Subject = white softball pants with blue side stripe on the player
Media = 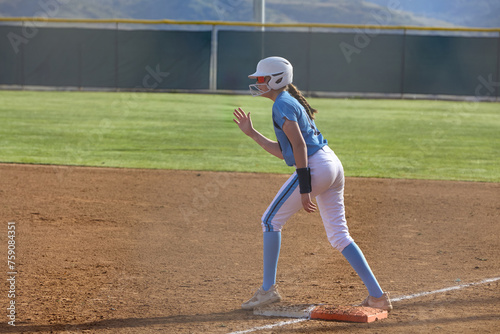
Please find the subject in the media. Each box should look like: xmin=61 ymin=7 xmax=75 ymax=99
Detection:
xmin=262 ymin=146 xmax=353 ymax=251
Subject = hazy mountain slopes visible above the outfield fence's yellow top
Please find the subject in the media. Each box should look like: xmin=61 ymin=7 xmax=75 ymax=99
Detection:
xmin=0 ymin=0 xmax=500 ymax=27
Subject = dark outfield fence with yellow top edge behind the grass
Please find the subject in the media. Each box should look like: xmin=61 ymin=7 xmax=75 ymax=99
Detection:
xmin=0 ymin=18 xmax=500 ymax=99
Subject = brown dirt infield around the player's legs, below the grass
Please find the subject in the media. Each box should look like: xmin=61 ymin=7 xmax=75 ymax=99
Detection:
xmin=0 ymin=165 xmax=500 ymax=333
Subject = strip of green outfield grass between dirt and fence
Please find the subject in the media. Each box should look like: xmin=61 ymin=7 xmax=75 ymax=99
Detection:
xmin=0 ymin=91 xmax=500 ymax=182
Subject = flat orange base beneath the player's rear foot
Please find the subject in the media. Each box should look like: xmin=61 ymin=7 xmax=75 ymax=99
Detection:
xmin=311 ymin=305 xmax=388 ymax=322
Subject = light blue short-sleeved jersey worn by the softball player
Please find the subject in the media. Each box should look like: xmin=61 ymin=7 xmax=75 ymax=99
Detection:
xmin=273 ymin=91 xmax=328 ymax=166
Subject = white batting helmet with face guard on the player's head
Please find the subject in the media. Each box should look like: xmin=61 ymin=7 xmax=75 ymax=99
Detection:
xmin=248 ymin=57 xmax=293 ymax=95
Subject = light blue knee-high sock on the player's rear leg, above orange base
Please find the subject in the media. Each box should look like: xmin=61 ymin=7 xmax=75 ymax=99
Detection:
xmin=342 ymin=242 xmax=384 ymax=298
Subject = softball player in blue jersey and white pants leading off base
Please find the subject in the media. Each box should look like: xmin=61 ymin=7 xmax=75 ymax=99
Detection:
xmin=233 ymin=57 xmax=392 ymax=311
